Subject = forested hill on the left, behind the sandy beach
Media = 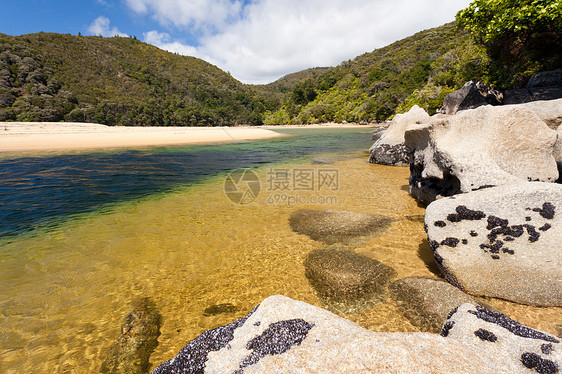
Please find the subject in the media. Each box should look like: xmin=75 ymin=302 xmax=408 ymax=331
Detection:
xmin=0 ymin=33 xmax=272 ymax=126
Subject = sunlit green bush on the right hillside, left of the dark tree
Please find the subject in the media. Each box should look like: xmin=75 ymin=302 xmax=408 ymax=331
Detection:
xmin=262 ymin=23 xmax=489 ymax=124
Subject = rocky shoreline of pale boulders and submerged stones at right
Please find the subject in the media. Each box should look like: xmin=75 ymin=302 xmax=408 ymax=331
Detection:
xmin=141 ymin=73 xmax=562 ymax=374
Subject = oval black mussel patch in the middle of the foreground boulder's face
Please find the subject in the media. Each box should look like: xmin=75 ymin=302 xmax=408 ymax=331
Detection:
xmin=234 ymin=318 xmax=314 ymax=374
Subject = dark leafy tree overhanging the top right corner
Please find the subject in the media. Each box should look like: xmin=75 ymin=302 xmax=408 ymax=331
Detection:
xmin=456 ymin=0 xmax=562 ymax=89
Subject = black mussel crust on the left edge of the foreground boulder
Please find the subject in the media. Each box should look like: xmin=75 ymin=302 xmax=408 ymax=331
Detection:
xmin=152 ymin=305 xmax=259 ymax=374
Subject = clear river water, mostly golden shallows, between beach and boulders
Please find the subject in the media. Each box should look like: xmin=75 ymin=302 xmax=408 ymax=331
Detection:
xmin=0 ymin=130 xmax=560 ymax=373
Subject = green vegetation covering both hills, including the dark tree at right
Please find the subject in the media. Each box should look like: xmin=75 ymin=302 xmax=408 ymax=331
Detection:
xmin=0 ymin=0 xmax=552 ymax=126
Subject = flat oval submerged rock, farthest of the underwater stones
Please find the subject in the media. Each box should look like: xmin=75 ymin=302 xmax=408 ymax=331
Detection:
xmin=289 ymin=209 xmax=392 ymax=244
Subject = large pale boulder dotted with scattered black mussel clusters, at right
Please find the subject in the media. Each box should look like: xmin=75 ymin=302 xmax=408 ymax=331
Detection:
xmin=425 ymin=183 xmax=562 ymax=306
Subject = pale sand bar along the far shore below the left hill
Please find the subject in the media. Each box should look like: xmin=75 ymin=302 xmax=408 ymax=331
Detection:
xmin=0 ymin=122 xmax=286 ymax=152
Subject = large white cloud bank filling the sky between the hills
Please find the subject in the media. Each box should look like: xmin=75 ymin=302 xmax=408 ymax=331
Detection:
xmin=135 ymin=0 xmax=470 ymax=83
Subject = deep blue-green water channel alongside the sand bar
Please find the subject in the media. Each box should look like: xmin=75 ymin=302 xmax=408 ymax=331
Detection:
xmin=0 ymin=129 xmax=371 ymax=238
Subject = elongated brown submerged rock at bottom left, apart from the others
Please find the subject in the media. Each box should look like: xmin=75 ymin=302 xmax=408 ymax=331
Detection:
xmin=101 ymin=297 xmax=162 ymax=374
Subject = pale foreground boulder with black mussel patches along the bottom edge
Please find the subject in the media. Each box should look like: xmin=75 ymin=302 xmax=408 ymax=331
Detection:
xmin=153 ymin=296 xmax=561 ymax=374
